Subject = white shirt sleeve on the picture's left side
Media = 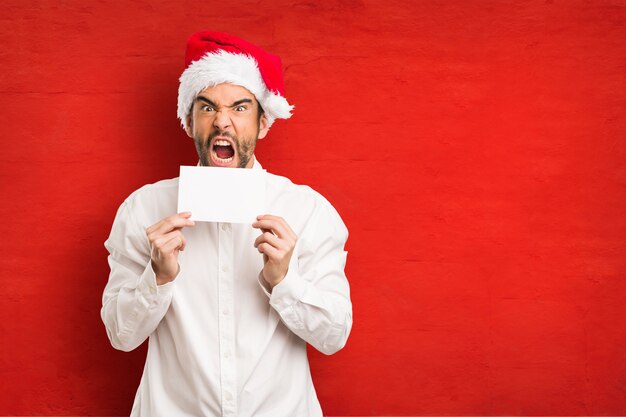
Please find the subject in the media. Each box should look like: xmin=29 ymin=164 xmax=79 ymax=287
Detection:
xmin=100 ymin=200 xmax=174 ymax=351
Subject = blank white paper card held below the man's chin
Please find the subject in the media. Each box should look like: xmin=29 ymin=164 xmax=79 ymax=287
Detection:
xmin=178 ymin=166 xmax=267 ymax=223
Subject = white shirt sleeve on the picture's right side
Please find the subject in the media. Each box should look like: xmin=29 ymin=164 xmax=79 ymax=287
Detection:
xmin=259 ymin=202 xmax=352 ymax=355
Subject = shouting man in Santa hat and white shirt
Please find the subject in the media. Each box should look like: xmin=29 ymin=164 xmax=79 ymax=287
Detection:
xmin=101 ymin=32 xmax=352 ymax=417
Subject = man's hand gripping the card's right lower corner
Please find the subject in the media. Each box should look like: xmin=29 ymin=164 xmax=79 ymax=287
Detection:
xmin=252 ymin=214 xmax=298 ymax=288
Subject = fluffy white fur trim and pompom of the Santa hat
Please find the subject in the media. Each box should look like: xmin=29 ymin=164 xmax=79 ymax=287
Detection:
xmin=178 ymin=51 xmax=294 ymax=132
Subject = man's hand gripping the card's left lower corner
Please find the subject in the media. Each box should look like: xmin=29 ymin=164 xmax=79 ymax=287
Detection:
xmin=146 ymin=212 xmax=195 ymax=285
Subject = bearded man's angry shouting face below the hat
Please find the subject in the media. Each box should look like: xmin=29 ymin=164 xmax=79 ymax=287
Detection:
xmin=186 ymin=83 xmax=268 ymax=168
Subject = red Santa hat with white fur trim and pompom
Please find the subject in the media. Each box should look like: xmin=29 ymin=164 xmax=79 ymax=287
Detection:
xmin=178 ymin=32 xmax=294 ymax=132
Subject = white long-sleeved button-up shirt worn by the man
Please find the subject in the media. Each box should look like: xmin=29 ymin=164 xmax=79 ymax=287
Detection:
xmin=101 ymin=161 xmax=352 ymax=417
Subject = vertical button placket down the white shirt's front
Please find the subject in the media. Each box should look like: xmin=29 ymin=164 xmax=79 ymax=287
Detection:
xmin=218 ymin=223 xmax=237 ymax=417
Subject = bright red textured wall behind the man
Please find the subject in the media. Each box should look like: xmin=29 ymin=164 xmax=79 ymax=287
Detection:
xmin=0 ymin=0 xmax=626 ymax=415
